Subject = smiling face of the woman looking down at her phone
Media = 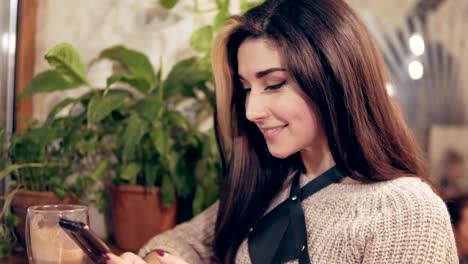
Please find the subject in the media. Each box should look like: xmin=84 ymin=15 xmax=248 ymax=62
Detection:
xmin=237 ymin=38 xmax=327 ymax=158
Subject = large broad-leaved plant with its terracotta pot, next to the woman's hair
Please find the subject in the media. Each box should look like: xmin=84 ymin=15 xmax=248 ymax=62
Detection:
xmin=93 ymin=43 xmax=221 ymax=251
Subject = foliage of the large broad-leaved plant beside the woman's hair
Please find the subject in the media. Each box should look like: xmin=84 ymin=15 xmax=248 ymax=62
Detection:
xmin=17 ymin=44 xmax=219 ymax=251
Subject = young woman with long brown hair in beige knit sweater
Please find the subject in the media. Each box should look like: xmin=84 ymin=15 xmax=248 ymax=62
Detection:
xmin=108 ymin=0 xmax=457 ymax=264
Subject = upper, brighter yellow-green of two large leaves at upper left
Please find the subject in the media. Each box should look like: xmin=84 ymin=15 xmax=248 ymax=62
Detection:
xmin=45 ymin=43 xmax=89 ymax=84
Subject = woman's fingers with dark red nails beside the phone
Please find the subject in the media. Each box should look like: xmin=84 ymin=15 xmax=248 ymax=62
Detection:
xmin=106 ymin=249 xmax=187 ymax=264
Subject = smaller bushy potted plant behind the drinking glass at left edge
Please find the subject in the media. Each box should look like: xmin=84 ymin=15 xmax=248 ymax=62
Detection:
xmin=0 ymin=118 xmax=82 ymax=253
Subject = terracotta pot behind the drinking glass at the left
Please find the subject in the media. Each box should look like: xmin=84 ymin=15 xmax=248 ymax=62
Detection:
xmin=11 ymin=190 xmax=79 ymax=242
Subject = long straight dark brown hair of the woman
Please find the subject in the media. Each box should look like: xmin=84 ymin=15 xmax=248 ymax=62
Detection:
xmin=212 ymin=0 xmax=426 ymax=263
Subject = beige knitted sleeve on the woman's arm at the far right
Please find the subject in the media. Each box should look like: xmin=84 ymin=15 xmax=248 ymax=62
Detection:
xmin=362 ymin=184 xmax=458 ymax=264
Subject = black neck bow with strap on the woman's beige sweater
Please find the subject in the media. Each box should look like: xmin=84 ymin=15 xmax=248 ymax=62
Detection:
xmin=248 ymin=166 xmax=344 ymax=264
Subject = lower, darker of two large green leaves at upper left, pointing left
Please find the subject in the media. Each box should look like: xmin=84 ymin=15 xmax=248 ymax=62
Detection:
xmin=19 ymin=70 xmax=83 ymax=100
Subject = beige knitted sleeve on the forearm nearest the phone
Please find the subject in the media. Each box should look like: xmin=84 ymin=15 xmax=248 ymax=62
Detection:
xmin=138 ymin=202 xmax=218 ymax=264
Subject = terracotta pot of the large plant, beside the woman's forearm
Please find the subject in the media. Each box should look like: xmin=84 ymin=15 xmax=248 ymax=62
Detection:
xmin=111 ymin=185 xmax=177 ymax=252
